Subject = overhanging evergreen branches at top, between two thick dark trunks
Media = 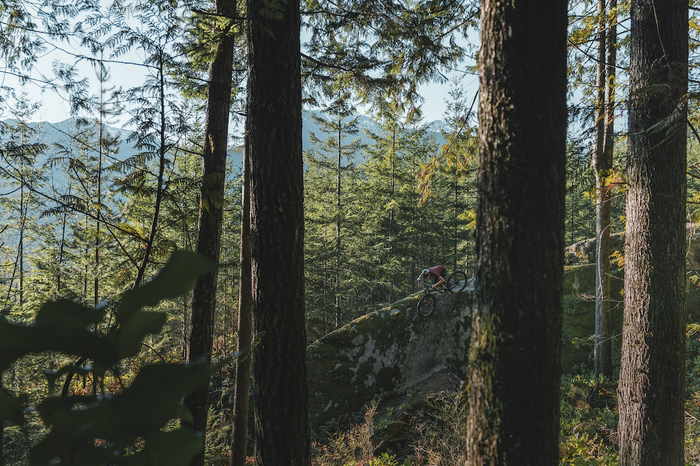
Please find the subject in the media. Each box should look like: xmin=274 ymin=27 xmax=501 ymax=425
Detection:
xmin=304 ymin=0 xmax=479 ymax=114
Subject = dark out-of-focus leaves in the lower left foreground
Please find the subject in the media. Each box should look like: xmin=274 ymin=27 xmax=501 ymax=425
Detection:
xmin=0 ymin=251 xmax=216 ymax=465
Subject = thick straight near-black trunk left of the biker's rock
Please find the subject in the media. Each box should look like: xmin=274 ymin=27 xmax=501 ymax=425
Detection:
xmin=246 ymin=0 xmax=311 ymax=466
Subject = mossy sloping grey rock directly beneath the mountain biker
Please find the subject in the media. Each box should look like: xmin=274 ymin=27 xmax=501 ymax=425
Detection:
xmin=307 ymin=283 xmax=473 ymax=428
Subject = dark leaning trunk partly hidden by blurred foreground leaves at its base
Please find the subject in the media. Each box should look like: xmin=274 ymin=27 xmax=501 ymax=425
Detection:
xmin=185 ymin=0 xmax=236 ymax=465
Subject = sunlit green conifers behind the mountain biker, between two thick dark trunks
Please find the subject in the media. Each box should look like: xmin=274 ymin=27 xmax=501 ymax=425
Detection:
xmin=304 ymin=104 xmax=475 ymax=337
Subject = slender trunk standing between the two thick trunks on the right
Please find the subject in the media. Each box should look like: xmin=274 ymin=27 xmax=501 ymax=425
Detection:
xmin=593 ymin=0 xmax=615 ymax=376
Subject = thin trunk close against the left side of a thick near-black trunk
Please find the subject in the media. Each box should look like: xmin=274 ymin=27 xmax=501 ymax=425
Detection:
xmin=231 ymin=140 xmax=253 ymax=466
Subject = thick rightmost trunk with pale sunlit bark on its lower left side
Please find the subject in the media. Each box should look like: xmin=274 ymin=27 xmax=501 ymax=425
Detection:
xmin=618 ymin=0 xmax=688 ymax=466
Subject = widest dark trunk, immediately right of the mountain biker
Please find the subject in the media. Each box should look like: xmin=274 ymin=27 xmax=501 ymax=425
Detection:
xmin=467 ymin=0 xmax=567 ymax=466
